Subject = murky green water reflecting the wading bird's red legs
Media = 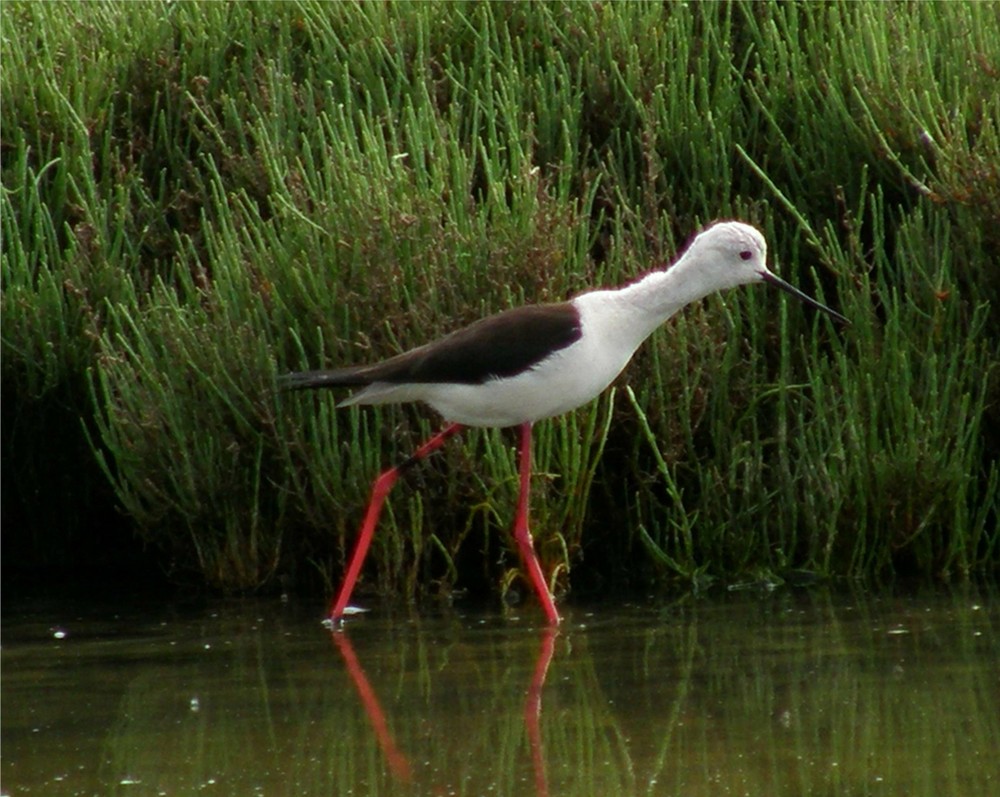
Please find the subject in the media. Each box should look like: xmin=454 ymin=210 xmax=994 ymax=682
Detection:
xmin=0 ymin=590 xmax=1000 ymax=797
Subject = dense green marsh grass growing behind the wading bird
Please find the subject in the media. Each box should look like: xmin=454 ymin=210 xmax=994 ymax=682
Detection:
xmin=0 ymin=2 xmax=1000 ymax=597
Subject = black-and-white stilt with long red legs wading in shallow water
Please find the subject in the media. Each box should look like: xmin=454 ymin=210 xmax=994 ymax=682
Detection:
xmin=282 ymin=221 xmax=847 ymax=624
